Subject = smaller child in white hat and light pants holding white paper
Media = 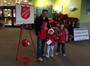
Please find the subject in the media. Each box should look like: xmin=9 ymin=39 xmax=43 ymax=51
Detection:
xmin=46 ymin=29 xmax=58 ymax=58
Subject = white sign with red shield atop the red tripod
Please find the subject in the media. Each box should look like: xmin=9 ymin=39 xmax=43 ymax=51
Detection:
xmin=16 ymin=4 xmax=34 ymax=24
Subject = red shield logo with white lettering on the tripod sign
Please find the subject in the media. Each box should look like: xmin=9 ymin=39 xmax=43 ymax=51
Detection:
xmin=21 ymin=5 xmax=30 ymax=20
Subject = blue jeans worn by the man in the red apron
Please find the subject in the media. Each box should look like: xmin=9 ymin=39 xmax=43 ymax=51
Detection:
xmin=37 ymin=40 xmax=45 ymax=58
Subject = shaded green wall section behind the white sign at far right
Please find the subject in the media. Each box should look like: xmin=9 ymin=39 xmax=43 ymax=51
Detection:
xmin=80 ymin=0 xmax=90 ymax=35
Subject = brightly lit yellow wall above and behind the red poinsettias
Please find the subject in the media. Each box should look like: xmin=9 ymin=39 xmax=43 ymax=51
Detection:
xmin=33 ymin=0 xmax=81 ymax=18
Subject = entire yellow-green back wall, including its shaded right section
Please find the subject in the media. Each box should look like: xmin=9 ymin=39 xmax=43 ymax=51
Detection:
xmin=33 ymin=0 xmax=90 ymax=34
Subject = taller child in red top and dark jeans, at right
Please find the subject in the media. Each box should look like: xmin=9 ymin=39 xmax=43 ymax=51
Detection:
xmin=56 ymin=24 xmax=66 ymax=56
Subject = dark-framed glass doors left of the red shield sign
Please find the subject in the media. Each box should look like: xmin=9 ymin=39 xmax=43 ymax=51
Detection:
xmin=0 ymin=6 xmax=19 ymax=27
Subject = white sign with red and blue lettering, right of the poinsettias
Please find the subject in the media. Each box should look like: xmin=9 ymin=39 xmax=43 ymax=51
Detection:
xmin=74 ymin=28 xmax=89 ymax=41
